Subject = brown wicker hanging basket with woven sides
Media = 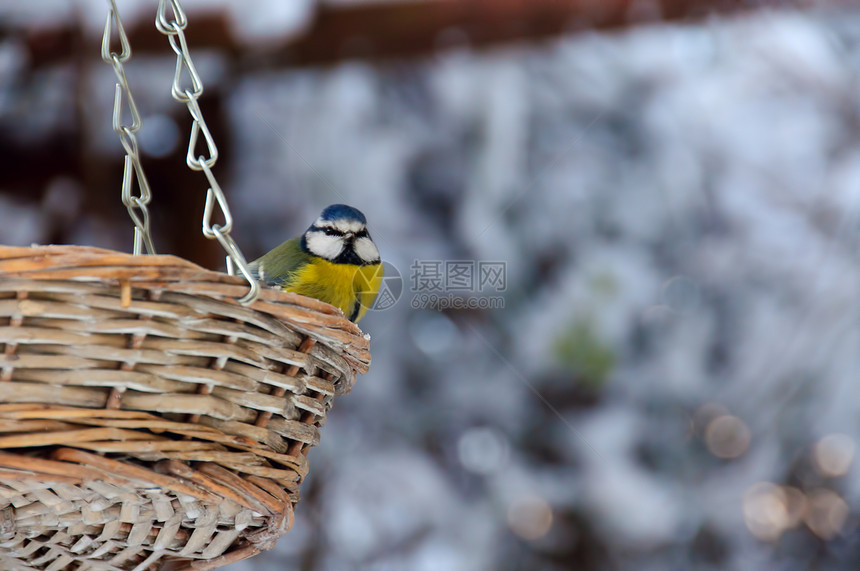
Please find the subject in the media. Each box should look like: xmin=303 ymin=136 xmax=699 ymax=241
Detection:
xmin=0 ymin=246 xmax=370 ymax=571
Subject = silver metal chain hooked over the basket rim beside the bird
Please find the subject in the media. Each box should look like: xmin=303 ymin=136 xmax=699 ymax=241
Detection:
xmin=155 ymin=0 xmax=260 ymax=305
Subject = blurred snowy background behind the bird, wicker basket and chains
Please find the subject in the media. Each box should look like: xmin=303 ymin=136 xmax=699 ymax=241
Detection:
xmin=0 ymin=0 xmax=860 ymax=571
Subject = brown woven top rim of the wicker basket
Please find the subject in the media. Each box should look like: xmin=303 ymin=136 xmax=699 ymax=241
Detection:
xmin=0 ymin=245 xmax=370 ymax=373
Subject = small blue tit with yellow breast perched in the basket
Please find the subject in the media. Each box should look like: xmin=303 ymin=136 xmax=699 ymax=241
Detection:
xmin=250 ymin=204 xmax=383 ymax=323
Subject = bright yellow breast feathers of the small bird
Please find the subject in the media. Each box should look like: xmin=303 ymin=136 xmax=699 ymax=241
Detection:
xmin=284 ymin=258 xmax=383 ymax=323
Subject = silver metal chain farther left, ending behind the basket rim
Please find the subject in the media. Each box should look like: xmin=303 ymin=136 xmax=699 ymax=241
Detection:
xmin=102 ymin=0 xmax=155 ymax=255
